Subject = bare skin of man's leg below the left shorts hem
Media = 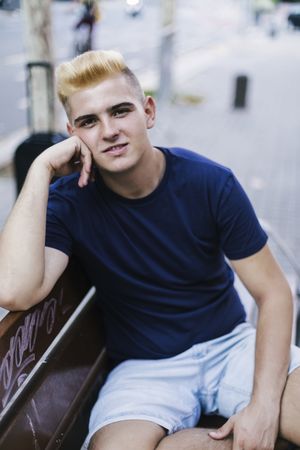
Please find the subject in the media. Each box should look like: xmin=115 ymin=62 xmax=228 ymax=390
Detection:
xmin=89 ymin=420 xmax=166 ymax=450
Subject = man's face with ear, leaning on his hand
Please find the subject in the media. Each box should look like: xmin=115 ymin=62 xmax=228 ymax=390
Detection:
xmin=68 ymin=75 xmax=155 ymax=173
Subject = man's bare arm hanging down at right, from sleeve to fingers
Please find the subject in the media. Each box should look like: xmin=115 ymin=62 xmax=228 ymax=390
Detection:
xmin=210 ymin=245 xmax=293 ymax=450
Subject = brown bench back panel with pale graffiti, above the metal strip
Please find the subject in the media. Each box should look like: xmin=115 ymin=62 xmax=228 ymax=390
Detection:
xmin=0 ymin=264 xmax=91 ymax=412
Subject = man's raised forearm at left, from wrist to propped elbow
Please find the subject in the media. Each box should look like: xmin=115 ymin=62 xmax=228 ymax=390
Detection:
xmin=0 ymin=161 xmax=51 ymax=309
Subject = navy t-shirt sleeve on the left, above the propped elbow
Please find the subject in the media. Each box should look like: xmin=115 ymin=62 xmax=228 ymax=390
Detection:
xmin=45 ymin=191 xmax=72 ymax=256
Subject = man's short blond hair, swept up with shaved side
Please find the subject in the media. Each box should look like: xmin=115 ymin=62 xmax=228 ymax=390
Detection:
xmin=56 ymin=50 xmax=144 ymax=108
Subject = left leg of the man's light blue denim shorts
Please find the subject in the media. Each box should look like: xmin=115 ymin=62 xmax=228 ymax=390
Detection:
xmin=83 ymin=354 xmax=200 ymax=449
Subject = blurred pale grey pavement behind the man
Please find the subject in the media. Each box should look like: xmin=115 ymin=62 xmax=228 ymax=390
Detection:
xmin=0 ymin=26 xmax=300 ymax=284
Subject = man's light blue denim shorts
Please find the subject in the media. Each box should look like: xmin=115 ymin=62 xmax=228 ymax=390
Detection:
xmin=83 ymin=323 xmax=300 ymax=449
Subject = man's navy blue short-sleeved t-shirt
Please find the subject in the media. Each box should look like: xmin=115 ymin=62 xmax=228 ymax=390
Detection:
xmin=46 ymin=148 xmax=267 ymax=361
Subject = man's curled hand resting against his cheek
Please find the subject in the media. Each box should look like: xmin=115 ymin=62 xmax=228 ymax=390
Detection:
xmin=34 ymin=136 xmax=92 ymax=187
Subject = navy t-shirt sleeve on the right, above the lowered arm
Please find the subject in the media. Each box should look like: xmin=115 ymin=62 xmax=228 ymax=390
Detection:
xmin=217 ymin=173 xmax=268 ymax=259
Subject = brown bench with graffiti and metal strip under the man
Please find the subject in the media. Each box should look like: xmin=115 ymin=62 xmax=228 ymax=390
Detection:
xmin=0 ymin=260 xmax=293 ymax=450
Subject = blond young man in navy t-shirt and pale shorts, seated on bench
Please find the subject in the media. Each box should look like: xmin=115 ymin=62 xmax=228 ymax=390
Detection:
xmin=0 ymin=51 xmax=300 ymax=450
